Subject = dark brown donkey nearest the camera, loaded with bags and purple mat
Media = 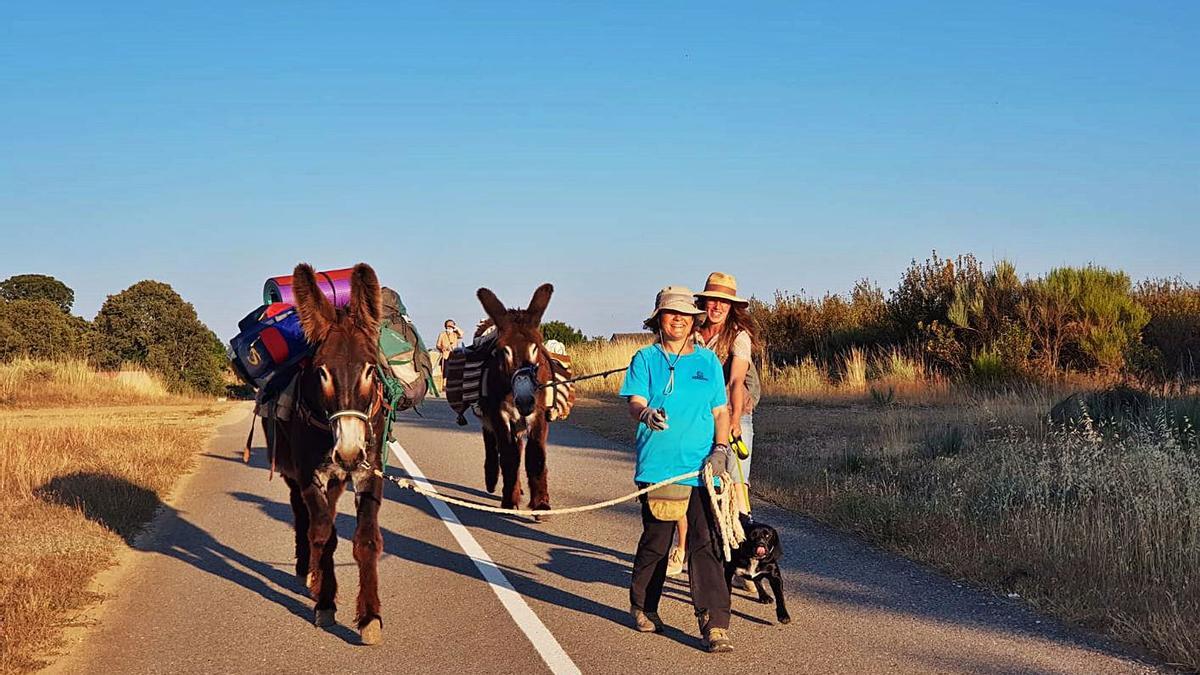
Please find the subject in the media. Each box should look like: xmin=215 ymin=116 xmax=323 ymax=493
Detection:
xmin=272 ymin=263 xmax=386 ymax=645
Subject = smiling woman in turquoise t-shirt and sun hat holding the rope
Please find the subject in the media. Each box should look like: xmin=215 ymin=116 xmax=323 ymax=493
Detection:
xmin=620 ymin=286 xmax=733 ymax=652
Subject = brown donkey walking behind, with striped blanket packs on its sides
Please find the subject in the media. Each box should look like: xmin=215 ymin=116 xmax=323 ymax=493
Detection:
xmin=476 ymin=283 xmax=554 ymax=510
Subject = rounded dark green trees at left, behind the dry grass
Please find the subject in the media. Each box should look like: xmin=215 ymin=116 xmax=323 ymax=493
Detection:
xmin=0 ymin=274 xmax=227 ymax=394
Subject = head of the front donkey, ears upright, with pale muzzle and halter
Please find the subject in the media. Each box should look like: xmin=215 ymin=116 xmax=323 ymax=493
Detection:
xmin=293 ymin=263 xmax=383 ymax=468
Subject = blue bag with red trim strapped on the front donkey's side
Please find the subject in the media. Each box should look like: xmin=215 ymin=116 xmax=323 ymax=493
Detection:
xmin=229 ymin=303 xmax=312 ymax=389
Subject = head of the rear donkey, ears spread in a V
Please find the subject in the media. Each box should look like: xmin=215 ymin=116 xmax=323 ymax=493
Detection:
xmin=476 ymin=283 xmax=554 ymax=416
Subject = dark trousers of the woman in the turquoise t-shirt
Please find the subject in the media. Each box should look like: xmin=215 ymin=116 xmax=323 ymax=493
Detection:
xmin=629 ymin=488 xmax=730 ymax=628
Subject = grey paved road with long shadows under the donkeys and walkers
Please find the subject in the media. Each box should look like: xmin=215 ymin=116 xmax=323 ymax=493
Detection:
xmin=53 ymin=401 xmax=1161 ymax=675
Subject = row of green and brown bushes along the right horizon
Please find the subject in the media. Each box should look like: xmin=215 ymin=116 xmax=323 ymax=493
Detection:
xmin=751 ymin=252 xmax=1200 ymax=380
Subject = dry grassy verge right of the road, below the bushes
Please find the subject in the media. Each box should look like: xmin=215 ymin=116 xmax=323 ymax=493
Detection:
xmin=561 ymin=338 xmax=1200 ymax=670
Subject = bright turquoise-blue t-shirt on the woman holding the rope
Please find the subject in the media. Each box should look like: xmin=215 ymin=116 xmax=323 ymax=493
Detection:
xmin=620 ymin=345 xmax=726 ymax=485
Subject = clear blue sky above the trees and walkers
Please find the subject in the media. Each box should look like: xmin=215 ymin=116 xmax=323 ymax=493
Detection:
xmin=0 ymin=0 xmax=1200 ymax=339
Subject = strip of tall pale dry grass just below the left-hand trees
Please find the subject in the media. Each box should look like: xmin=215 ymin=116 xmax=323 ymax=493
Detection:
xmin=0 ymin=358 xmax=186 ymax=407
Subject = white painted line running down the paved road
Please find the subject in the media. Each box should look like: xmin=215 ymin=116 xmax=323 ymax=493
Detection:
xmin=388 ymin=441 xmax=581 ymax=675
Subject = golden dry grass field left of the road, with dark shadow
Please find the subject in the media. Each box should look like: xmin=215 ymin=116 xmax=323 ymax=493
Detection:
xmin=0 ymin=362 xmax=221 ymax=673
